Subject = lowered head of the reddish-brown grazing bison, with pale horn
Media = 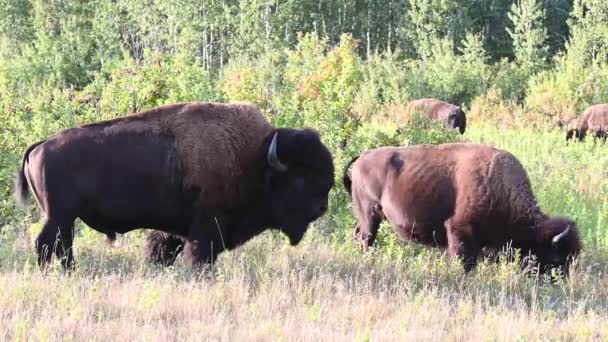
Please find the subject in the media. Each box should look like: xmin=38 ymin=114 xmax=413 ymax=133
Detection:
xmin=532 ymin=218 xmax=581 ymax=273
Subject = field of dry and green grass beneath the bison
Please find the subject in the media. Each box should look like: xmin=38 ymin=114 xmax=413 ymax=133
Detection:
xmin=0 ymin=127 xmax=608 ymax=341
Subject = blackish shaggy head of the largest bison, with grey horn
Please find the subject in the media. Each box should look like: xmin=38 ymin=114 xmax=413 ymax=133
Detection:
xmin=265 ymin=128 xmax=334 ymax=245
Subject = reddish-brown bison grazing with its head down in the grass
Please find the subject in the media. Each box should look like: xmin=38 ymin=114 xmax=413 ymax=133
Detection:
xmin=343 ymin=143 xmax=581 ymax=271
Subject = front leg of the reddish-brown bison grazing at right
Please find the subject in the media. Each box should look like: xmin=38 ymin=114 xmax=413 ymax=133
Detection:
xmin=445 ymin=220 xmax=481 ymax=273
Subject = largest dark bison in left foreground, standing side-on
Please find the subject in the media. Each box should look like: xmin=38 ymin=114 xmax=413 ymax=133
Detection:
xmin=16 ymin=103 xmax=334 ymax=268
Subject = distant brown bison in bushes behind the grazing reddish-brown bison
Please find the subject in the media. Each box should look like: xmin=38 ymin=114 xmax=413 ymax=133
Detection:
xmin=406 ymin=99 xmax=467 ymax=134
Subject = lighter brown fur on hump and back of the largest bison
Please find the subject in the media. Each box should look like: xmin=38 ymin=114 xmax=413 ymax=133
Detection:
xmin=85 ymin=102 xmax=273 ymax=208
